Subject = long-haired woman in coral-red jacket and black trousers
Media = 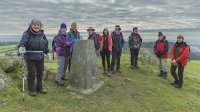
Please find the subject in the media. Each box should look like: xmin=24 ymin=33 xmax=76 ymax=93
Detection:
xmin=99 ymin=28 xmax=112 ymax=76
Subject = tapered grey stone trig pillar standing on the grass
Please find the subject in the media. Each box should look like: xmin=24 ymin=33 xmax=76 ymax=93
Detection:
xmin=68 ymin=40 xmax=103 ymax=94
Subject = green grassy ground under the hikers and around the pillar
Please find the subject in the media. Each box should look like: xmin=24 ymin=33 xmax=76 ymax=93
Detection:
xmin=0 ymin=54 xmax=200 ymax=112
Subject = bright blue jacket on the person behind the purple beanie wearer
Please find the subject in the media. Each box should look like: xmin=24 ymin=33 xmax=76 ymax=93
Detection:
xmin=67 ymin=30 xmax=80 ymax=46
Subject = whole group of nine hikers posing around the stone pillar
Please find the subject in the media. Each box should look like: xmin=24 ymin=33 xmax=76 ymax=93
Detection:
xmin=18 ymin=19 xmax=189 ymax=96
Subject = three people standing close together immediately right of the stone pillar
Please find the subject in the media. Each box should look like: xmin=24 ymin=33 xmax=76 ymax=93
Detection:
xmin=87 ymin=25 xmax=125 ymax=76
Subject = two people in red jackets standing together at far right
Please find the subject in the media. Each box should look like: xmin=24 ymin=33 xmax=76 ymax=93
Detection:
xmin=154 ymin=32 xmax=190 ymax=88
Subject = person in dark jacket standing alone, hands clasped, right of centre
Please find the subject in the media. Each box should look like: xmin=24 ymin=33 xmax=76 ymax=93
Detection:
xmin=129 ymin=27 xmax=142 ymax=68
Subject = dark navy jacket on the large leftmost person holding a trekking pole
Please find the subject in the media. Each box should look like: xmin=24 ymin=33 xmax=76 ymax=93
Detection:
xmin=19 ymin=27 xmax=49 ymax=60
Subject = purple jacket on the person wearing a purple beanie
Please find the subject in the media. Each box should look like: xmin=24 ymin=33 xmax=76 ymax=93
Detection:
xmin=56 ymin=32 xmax=72 ymax=56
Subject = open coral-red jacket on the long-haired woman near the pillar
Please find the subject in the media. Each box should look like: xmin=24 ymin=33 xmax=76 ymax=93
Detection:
xmin=99 ymin=35 xmax=112 ymax=52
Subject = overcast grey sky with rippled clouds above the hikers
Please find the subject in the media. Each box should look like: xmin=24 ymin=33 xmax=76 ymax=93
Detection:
xmin=0 ymin=0 xmax=200 ymax=34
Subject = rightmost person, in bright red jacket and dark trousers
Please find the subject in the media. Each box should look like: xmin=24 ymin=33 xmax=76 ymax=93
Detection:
xmin=171 ymin=35 xmax=190 ymax=88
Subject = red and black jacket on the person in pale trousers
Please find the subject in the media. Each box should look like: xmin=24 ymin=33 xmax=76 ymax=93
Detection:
xmin=154 ymin=37 xmax=169 ymax=59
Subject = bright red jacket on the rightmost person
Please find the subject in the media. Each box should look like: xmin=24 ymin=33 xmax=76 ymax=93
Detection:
xmin=170 ymin=42 xmax=190 ymax=66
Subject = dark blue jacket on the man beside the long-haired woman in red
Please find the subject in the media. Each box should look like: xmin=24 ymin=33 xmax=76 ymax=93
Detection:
xmin=111 ymin=32 xmax=125 ymax=53
